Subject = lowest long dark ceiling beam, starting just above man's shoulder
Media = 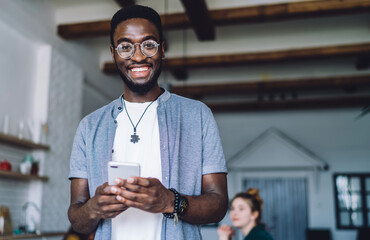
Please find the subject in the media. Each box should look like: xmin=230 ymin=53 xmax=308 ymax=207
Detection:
xmin=206 ymin=96 xmax=370 ymax=113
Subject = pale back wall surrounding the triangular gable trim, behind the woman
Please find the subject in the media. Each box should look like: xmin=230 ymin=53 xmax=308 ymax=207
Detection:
xmin=205 ymin=108 xmax=370 ymax=240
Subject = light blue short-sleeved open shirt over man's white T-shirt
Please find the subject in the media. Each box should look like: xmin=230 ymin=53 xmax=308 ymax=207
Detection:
xmin=69 ymin=91 xmax=227 ymax=240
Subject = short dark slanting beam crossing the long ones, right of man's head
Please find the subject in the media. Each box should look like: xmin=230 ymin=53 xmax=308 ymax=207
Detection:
xmin=181 ymin=0 xmax=215 ymax=41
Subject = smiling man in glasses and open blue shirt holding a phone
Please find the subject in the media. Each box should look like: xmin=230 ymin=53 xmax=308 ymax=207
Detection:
xmin=68 ymin=5 xmax=228 ymax=240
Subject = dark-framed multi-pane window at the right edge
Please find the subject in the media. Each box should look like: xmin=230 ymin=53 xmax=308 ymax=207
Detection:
xmin=334 ymin=173 xmax=370 ymax=229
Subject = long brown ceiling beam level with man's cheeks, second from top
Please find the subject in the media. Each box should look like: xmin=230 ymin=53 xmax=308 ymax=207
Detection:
xmin=103 ymin=43 xmax=370 ymax=74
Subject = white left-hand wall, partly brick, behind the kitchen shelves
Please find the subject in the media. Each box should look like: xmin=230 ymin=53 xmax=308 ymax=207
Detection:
xmin=0 ymin=0 xmax=84 ymax=234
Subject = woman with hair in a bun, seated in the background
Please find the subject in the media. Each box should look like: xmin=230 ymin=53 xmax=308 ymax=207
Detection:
xmin=217 ymin=188 xmax=273 ymax=240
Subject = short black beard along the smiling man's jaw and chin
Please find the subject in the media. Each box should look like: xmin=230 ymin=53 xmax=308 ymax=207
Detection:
xmin=114 ymin=59 xmax=162 ymax=95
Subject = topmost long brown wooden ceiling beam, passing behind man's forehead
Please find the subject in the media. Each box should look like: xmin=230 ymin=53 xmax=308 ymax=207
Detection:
xmin=58 ymin=0 xmax=370 ymax=39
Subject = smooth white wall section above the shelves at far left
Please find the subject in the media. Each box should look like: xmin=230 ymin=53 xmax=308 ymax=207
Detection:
xmin=0 ymin=17 xmax=39 ymax=135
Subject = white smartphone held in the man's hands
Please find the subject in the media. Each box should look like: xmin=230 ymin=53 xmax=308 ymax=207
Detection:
xmin=108 ymin=161 xmax=140 ymax=185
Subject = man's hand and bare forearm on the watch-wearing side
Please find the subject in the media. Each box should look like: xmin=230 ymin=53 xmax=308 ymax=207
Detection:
xmin=109 ymin=173 xmax=228 ymax=224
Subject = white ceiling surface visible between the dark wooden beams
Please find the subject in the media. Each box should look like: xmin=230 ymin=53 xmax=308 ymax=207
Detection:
xmin=31 ymin=0 xmax=370 ymax=103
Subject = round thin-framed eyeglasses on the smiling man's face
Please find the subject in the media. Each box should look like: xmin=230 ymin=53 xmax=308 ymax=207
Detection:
xmin=116 ymin=40 xmax=160 ymax=59
